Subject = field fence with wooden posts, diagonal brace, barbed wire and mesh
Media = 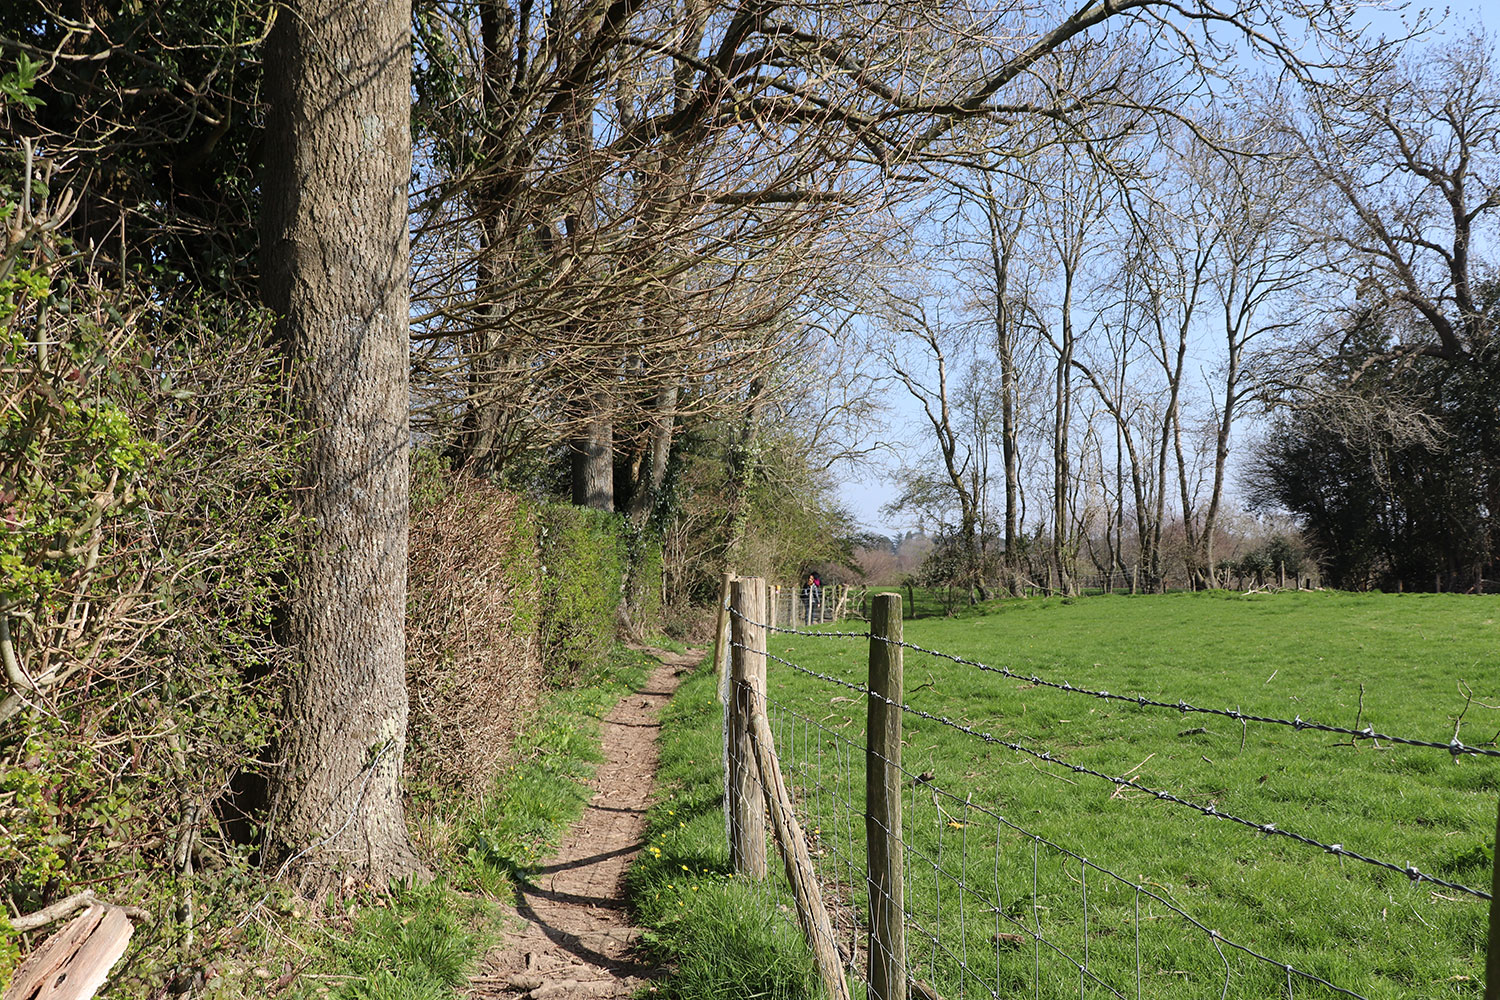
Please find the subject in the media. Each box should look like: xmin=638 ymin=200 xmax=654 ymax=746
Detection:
xmin=716 ymin=574 xmax=1500 ymax=1000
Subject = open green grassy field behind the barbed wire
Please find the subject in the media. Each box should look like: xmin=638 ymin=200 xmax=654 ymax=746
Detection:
xmin=741 ymin=592 xmax=1500 ymax=999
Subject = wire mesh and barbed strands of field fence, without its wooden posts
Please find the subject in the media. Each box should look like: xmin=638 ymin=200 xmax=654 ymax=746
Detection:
xmin=728 ymin=578 xmax=1496 ymax=1000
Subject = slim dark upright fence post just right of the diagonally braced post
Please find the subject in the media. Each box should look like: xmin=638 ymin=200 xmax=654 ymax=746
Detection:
xmin=864 ymin=594 xmax=906 ymax=1000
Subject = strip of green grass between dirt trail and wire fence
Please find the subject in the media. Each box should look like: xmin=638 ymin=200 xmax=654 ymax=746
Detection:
xmin=626 ymin=660 xmax=818 ymax=1000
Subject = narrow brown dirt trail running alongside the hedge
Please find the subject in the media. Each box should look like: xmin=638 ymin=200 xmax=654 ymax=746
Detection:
xmin=465 ymin=649 xmax=704 ymax=1000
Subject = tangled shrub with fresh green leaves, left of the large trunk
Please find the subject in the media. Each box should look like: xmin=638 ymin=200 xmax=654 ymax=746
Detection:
xmin=0 ymin=176 xmax=297 ymax=993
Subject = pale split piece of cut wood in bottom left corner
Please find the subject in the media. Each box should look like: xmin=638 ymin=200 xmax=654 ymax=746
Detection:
xmin=5 ymin=903 xmax=135 ymax=1000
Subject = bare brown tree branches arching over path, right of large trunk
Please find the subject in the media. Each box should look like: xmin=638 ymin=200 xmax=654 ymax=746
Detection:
xmin=405 ymin=0 xmax=1368 ymax=517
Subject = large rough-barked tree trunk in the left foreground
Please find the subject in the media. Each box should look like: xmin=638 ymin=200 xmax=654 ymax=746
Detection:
xmin=263 ymin=0 xmax=420 ymax=889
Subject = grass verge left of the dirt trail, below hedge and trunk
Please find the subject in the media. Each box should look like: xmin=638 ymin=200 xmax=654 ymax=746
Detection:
xmin=214 ymin=649 xmax=654 ymax=1000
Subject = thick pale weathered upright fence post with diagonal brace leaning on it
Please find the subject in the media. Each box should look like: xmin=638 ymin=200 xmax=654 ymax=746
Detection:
xmin=728 ymin=577 xmax=767 ymax=879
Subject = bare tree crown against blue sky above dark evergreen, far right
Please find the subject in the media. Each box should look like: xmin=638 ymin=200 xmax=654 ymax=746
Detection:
xmin=1277 ymin=31 xmax=1500 ymax=361
